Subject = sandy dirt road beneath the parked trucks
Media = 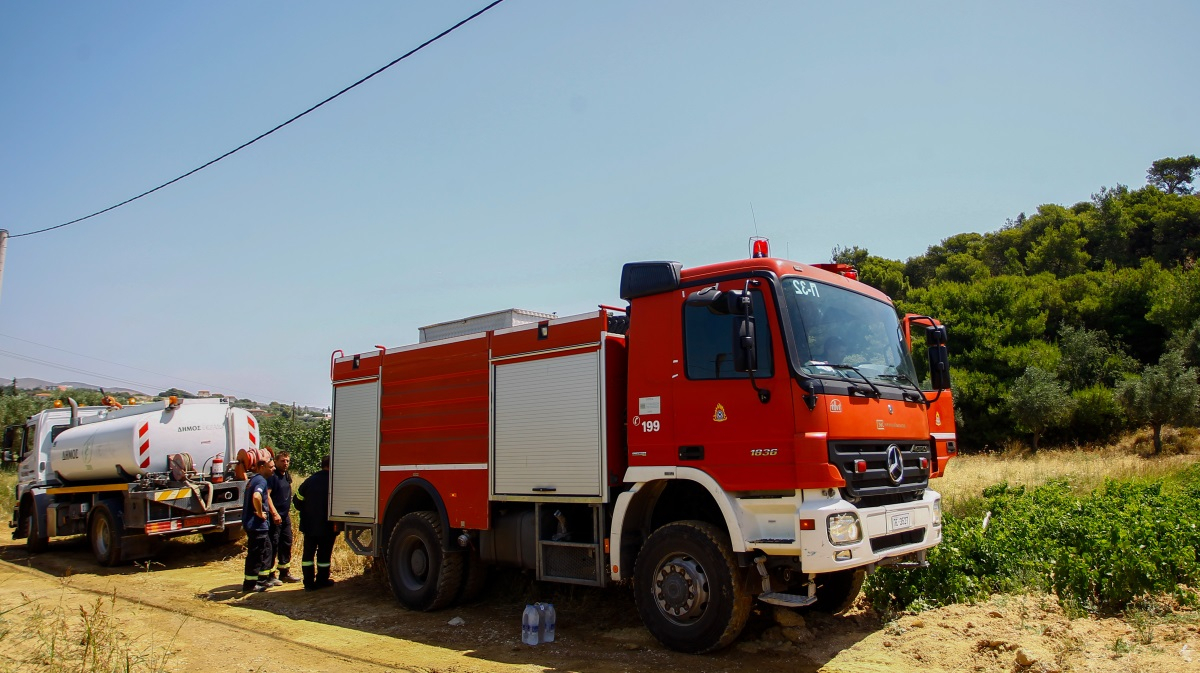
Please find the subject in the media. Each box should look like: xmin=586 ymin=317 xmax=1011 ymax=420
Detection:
xmin=0 ymin=532 xmax=1200 ymax=673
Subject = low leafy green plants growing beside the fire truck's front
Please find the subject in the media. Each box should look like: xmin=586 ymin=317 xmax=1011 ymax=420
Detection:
xmin=866 ymin=465 xmax=1200 ymax=613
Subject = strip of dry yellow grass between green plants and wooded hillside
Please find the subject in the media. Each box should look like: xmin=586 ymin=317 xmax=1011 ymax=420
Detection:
xmin=934 ymin=428 xmax=1200 ymax=512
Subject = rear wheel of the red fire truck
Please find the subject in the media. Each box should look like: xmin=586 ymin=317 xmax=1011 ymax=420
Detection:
xmin=388 ymin=512 xmax=462 ymax=612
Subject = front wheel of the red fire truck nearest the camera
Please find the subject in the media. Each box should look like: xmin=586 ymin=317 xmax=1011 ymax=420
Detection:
xmin=634 ymin=521 xmax=752 ymax=654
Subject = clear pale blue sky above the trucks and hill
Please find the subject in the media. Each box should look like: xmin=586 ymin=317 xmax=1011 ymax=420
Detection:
xmin=0 ymin=0 xmax=1200 ymax=405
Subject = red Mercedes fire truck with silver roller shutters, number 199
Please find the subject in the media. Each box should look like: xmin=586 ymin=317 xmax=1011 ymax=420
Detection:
xmin=330 ymin=241 xmax=956 ymax=653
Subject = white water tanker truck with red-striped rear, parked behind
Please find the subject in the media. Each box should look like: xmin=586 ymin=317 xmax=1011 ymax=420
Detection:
xmin=2 ymin=397 xmax=260 ymax=565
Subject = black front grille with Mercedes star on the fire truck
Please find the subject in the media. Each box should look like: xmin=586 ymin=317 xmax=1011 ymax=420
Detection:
xmin=829 ymin=440 xmax=932 ymax=507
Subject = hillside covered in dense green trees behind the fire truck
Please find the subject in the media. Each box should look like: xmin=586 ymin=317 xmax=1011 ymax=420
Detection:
xmin=833 ymin=155 xmax=1200 ymax=452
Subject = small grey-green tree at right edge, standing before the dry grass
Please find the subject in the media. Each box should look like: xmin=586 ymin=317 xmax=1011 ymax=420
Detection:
xmin=1117 ymin=350 xmax=1200 ymax=455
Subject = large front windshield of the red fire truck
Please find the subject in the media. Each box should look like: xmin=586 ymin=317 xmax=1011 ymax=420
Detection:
xmin=781 ymin=276 xmax=917 ymax=387
